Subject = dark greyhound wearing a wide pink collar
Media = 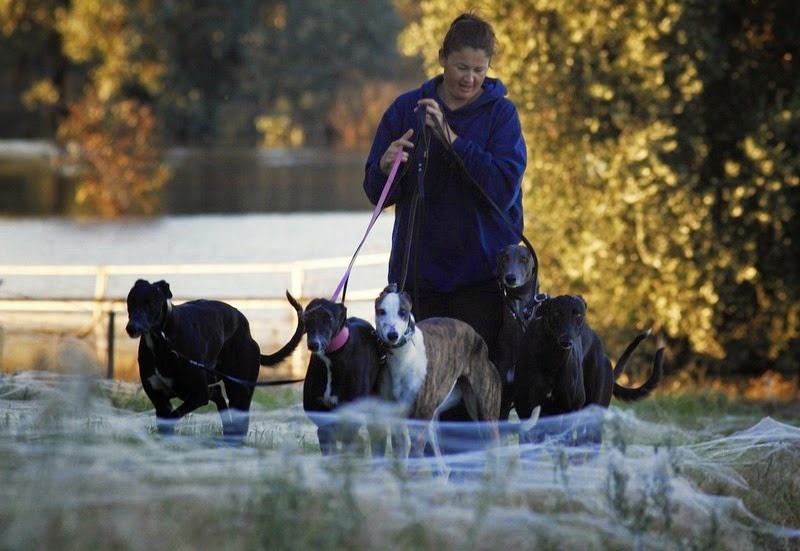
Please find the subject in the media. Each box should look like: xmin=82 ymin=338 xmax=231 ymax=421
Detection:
xmin=289 ymin=295 xmax=386 ymax=456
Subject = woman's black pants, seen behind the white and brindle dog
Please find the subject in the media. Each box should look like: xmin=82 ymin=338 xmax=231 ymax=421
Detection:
xmin=406 ymin=280 xmax=503 ymax=432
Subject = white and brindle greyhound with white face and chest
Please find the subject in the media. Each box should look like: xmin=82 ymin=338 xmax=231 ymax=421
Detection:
xmin=375 ymin=284 xmax=501 ymax=458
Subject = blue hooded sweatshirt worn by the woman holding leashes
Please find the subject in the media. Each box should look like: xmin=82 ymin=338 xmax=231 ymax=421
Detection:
xmin=364 ymin=75 xmax=527 ymax=293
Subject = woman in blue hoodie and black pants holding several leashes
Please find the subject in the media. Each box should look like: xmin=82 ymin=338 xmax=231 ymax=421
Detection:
xmin=364 ymin=14 xmax=527 ymax=357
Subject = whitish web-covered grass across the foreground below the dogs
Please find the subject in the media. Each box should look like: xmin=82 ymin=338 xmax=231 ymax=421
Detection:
xmin=0 ymin=372 xmax=800 ymax=549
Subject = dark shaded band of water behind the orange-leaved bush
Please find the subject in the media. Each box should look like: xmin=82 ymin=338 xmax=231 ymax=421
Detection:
xmin=0 ymin=141 xmax=371 ymax=216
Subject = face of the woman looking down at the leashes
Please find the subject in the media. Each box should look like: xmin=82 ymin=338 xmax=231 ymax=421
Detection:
xmin=439 ymin=48 xmax=490 ymax=109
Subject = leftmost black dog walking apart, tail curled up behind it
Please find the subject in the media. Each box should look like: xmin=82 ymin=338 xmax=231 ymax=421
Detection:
xmin=125 ymin=279 xmax=303 ymax=439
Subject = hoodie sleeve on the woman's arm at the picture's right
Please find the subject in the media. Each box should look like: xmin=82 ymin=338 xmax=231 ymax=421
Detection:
xmin=453 ymin=100 xmax=527 ymax=211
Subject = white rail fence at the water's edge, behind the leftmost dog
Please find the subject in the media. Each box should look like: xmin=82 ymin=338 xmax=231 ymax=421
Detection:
xmin=0 ymin=253 xmax=389 ymax=377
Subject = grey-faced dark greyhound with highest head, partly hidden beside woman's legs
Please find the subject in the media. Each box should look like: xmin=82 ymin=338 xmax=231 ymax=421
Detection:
xmin=492 ymin=245 xmax=542 ymax=421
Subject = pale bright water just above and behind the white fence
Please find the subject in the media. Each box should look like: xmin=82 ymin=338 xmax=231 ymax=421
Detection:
xmin=0 ymin=211 xmax=394 ymax=298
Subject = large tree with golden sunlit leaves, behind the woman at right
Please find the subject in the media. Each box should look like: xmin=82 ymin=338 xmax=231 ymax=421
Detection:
xmin=402 ymin=0 xmax=800 ymax=376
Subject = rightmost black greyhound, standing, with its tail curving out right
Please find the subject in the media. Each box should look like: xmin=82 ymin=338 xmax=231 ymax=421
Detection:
xmin=514 ymin=295 xmax=664 ymax=443
